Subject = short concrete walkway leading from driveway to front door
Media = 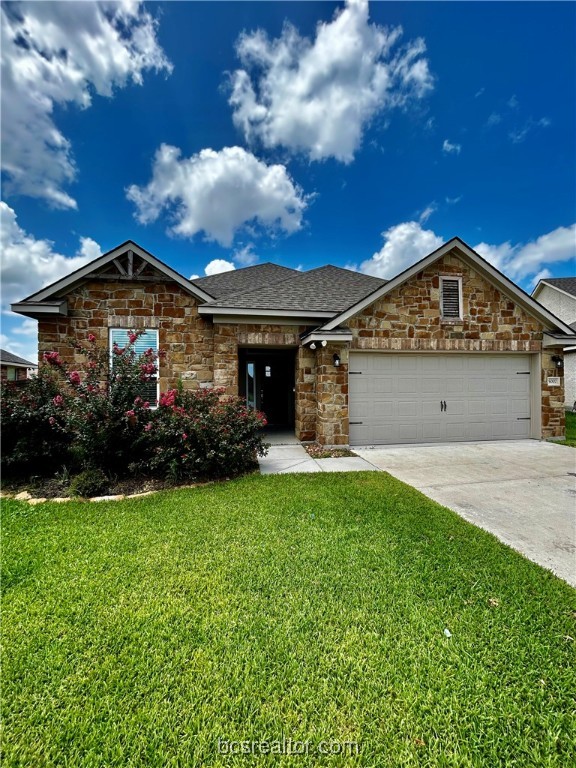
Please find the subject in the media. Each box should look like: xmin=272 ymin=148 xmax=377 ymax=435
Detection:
xmin=258 ymin=433 xmax=378 ymax=475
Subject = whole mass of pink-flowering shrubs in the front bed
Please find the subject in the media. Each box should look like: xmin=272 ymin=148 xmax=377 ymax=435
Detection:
xmin=1 ymin=331 xmax=267 ymax=495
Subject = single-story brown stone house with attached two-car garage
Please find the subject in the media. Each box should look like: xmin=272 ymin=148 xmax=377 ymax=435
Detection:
xmin=12 ymin=238 xmax=576 ymax=445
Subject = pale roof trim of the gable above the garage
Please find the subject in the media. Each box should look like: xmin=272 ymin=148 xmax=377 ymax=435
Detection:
xmin=323 ymin=237 xmax=573 ymax=335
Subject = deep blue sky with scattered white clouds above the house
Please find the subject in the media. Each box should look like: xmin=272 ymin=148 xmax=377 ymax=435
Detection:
xmin=0 ymin=0 xmax=576 ymax=359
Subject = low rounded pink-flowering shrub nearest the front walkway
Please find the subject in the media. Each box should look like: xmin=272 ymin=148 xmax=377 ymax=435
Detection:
xmin=144 ymin=389 xmax=267 ymax=480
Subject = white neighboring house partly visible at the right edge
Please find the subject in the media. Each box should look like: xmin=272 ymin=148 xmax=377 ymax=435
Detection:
xmin=532 ymin=277 xmax=576 ymax=408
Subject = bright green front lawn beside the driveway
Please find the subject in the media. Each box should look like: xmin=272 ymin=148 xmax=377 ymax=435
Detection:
xmin=2 ymin=473 xmax=576 ymax=768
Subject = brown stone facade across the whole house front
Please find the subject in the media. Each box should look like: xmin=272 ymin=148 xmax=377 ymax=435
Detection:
xmin=39 ymin=252 xmax=564 ymax=446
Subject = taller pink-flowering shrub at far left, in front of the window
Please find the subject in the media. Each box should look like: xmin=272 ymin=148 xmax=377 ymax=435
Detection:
xmin=2 ymin=331 xmax=157 ymax=476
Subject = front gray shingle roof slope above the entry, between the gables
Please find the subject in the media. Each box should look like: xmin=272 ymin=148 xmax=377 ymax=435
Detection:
xmin=205 ymin=265 xmax=386 ymax=313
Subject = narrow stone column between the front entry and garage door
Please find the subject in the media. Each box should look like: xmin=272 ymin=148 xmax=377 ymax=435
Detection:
xmin=316 ymin=344 xmax=349 ymax=446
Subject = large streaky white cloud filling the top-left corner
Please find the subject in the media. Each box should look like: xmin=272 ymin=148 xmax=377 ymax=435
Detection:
xmin=1 ymin=0 xmax=171 ymax=208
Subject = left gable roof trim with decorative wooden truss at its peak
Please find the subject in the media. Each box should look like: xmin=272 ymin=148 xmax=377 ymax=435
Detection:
xmin=13 ymin=240 xmax=213 ymax=312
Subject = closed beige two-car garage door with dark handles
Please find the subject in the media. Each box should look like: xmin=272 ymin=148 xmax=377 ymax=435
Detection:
xmin=349 ymin=352 xmax=530 ymax=445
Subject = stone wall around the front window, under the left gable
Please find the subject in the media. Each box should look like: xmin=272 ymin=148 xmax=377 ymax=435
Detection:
xmin=38 ymin=279 xmax=214 ymax=392
